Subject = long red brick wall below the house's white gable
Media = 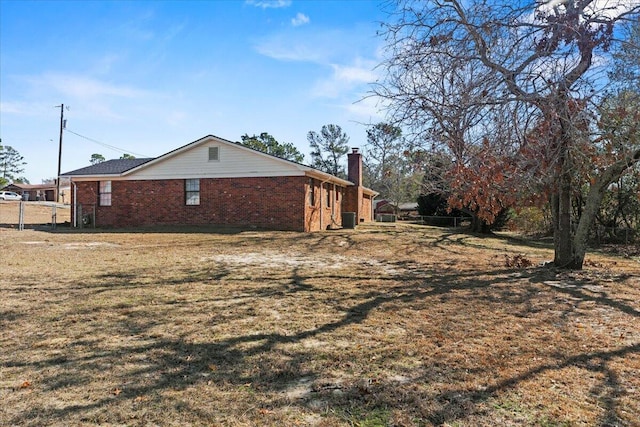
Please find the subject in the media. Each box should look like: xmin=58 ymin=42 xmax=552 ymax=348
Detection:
xmin=71 ymin=177 xmax=308 ymax=231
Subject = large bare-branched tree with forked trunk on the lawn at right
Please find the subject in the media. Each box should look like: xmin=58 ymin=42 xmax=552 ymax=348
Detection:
xmin=376 ymin=0 xmax=640 ymax=269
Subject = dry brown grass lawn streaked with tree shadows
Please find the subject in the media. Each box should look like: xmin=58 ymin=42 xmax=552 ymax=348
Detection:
xmin=0 ymin=222 xmax=640 ymax=426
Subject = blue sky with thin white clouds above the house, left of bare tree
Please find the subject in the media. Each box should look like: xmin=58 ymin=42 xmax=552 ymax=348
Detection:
xmin=0 ymin=0 xmax=386 ymax=184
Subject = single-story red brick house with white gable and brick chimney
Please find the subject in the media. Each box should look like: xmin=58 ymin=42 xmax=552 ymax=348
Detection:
xmin=62 ymin=135 xmax=377 ymax=231
